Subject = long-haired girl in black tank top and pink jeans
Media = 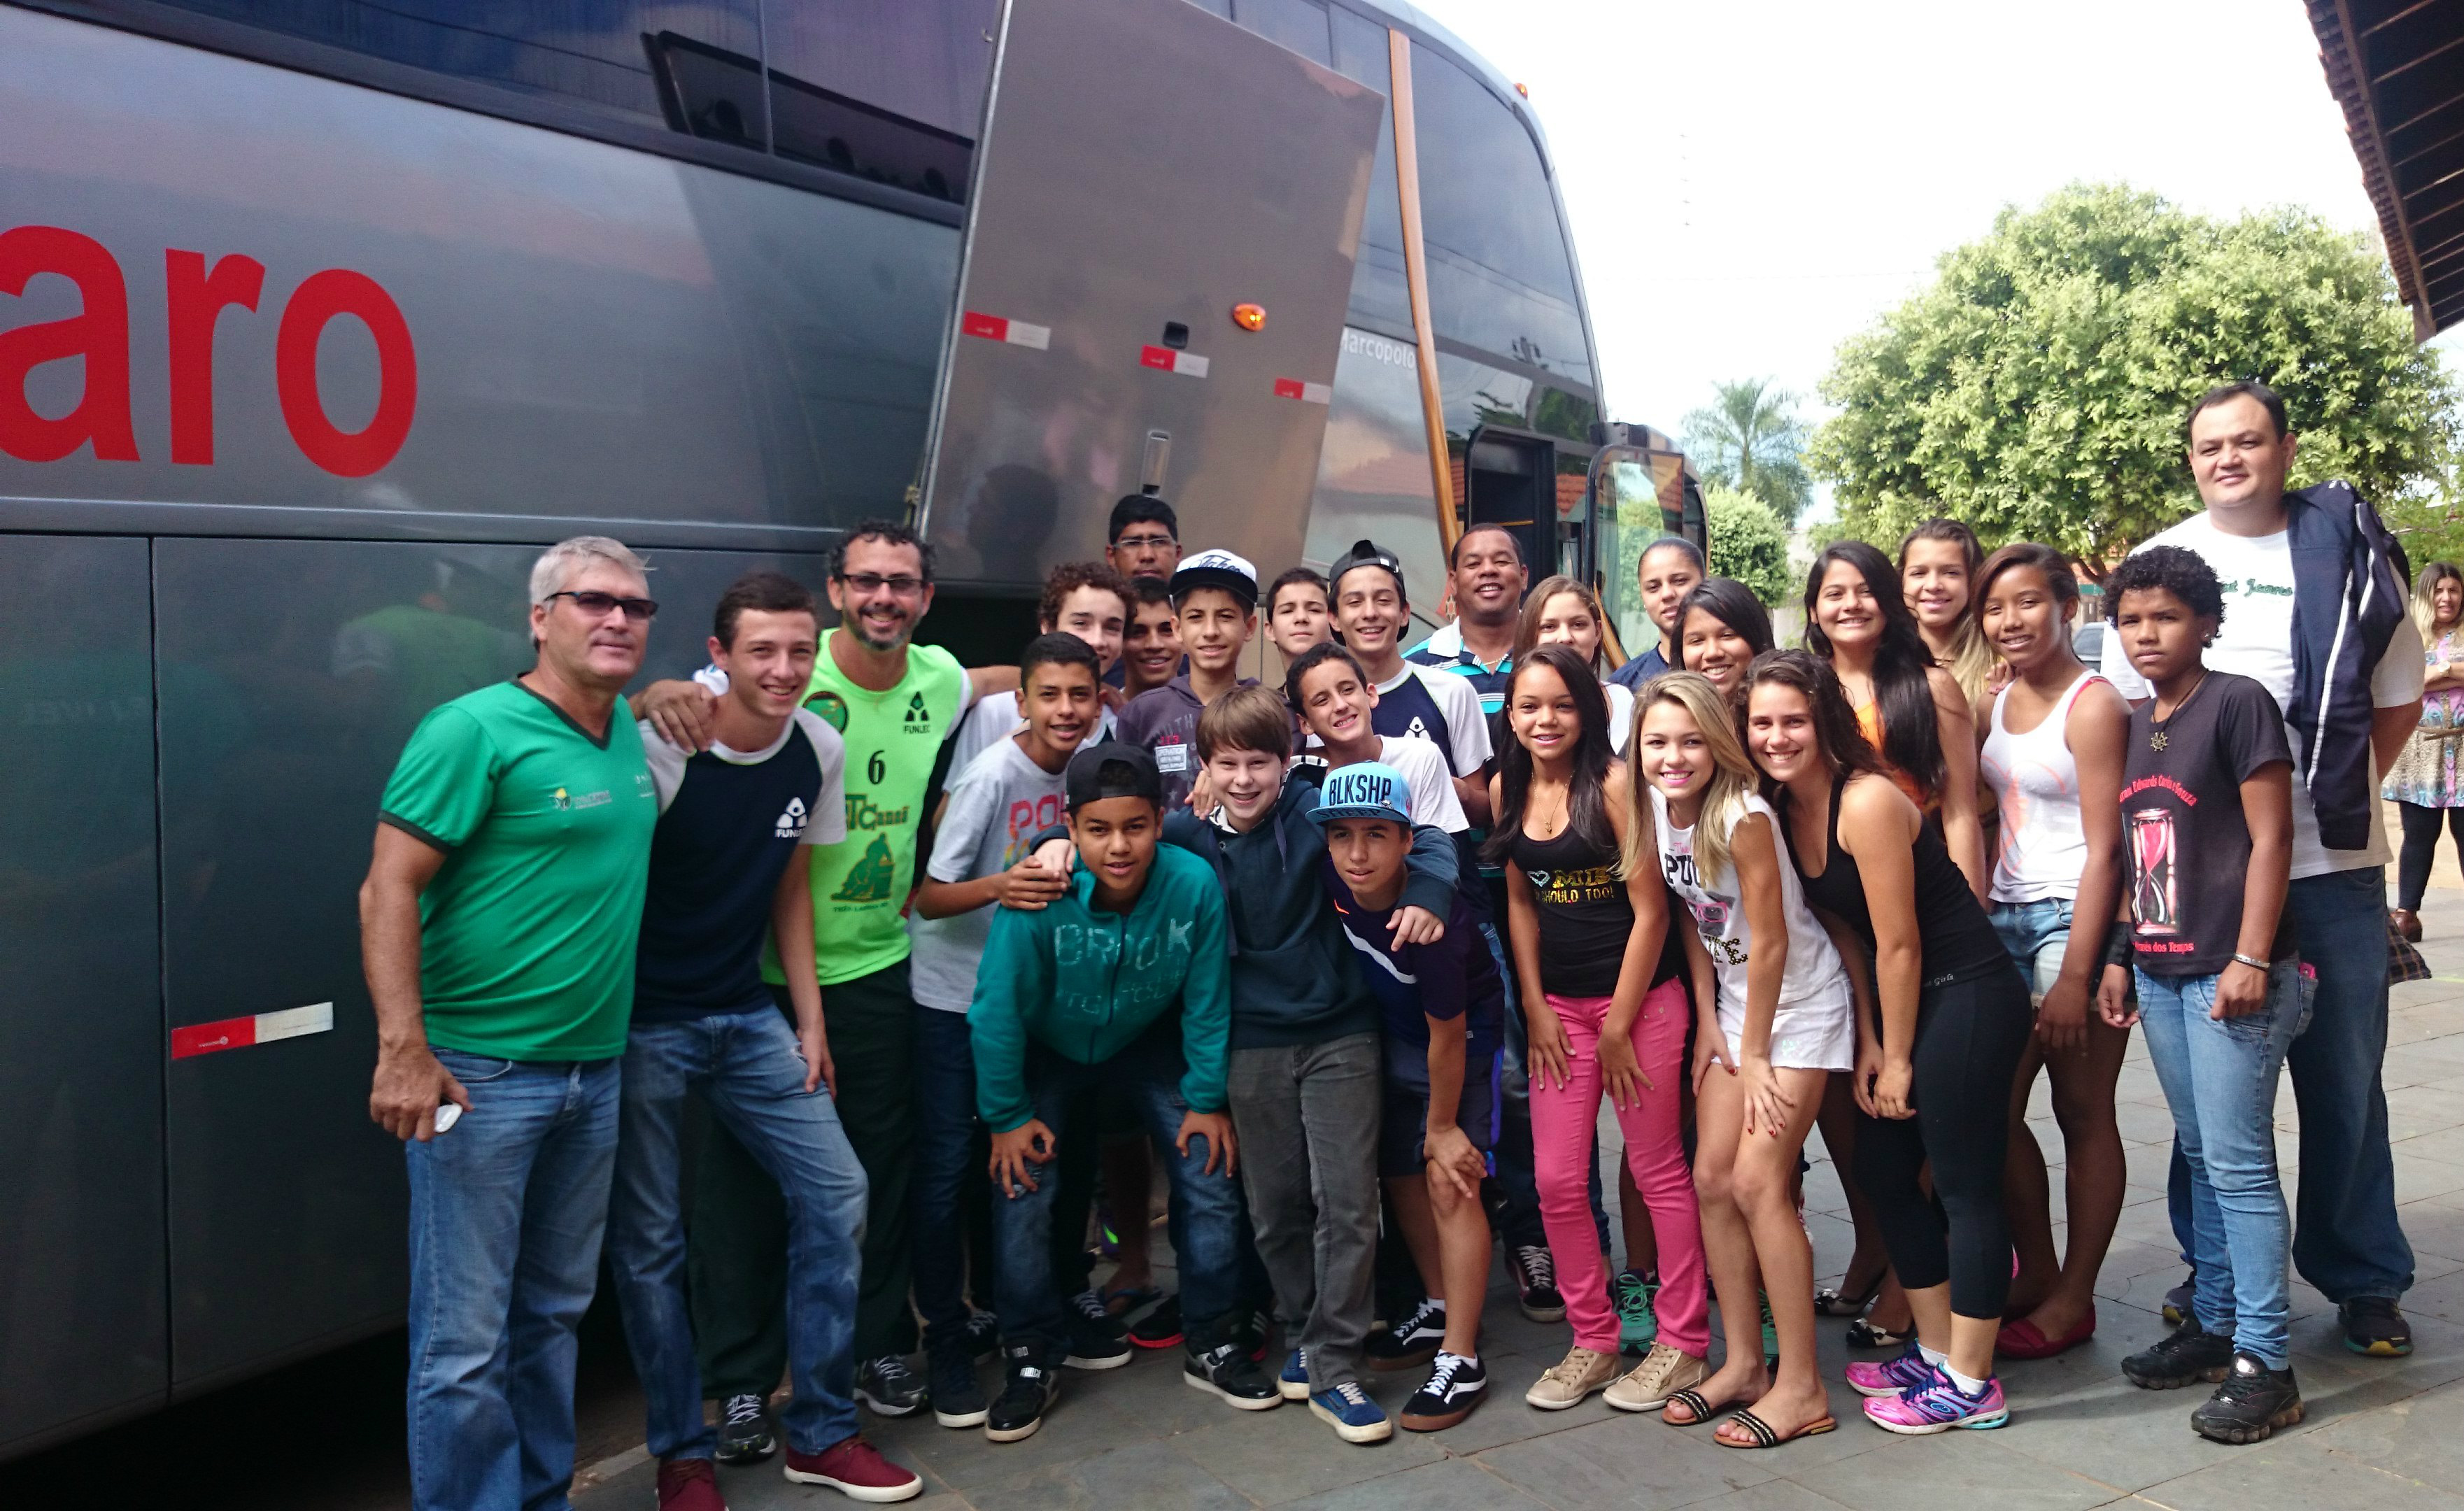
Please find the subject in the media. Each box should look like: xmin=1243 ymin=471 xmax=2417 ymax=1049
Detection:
xmin=1488 ymin=644 xmax=1710 ymax=1410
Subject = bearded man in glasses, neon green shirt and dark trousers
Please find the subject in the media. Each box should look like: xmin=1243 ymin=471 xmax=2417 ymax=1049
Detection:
xmin=636 ymin=520 xmax=995 ymax=1429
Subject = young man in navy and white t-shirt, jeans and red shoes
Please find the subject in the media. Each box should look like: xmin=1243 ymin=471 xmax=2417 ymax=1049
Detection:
xmin=609 ymin=572 xmax=924 ymax=1511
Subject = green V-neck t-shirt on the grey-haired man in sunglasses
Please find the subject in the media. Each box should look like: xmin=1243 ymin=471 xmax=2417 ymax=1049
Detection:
xmin=379 ymin=683 xmax=658 ymax=1060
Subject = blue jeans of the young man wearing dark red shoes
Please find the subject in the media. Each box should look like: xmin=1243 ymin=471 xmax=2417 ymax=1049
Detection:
xmin=609 ymin=1003 xmax=865 ymax=1459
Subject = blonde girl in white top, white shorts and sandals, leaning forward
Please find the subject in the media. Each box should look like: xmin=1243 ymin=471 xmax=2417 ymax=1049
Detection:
xmin=1627 ymin=670 xmax=1855 ymax=1447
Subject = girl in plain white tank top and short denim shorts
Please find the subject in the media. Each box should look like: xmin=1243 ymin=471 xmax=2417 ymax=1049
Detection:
xmin=1976 ymin=542 xmax=2132 ymax=1359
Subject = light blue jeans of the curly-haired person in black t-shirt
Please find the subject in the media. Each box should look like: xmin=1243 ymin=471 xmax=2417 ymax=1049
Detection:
xmin=2137 ymin=961 xmax=2309 ymax=1370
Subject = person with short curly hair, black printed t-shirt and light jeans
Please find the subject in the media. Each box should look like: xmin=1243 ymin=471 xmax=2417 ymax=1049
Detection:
xmin=2097 ymin=545 xmax=2309 ymax=1442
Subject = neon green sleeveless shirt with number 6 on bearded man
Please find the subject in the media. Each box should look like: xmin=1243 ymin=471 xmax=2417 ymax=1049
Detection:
xmin=793 ymin=629 xmax=966 ymax=986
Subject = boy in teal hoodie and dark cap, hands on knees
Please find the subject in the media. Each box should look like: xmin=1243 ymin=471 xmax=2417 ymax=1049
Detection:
xmin=966 ymin=742 xmax=1281 ymax=1442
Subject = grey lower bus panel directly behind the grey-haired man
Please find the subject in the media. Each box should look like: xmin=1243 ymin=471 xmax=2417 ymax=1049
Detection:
xmin=155 ymin=540 xmax=823 ymax=1383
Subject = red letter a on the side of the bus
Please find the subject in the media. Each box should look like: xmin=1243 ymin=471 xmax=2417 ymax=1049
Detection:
xmin=0 ymin=227 xmax=138 ymax=461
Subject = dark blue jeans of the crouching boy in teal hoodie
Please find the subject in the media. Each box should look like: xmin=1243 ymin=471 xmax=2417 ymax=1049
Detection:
xmin=993 ymin=1021 xmax=1247 ymax=1348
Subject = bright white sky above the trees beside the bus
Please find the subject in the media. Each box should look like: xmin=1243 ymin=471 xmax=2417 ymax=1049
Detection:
xmin=1419 ymin=0 xmax=2464 ymax=448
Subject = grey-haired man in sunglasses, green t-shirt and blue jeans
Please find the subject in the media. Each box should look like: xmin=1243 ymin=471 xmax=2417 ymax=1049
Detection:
xmin=360 ymin=535 xmax=658 ymax=1511
